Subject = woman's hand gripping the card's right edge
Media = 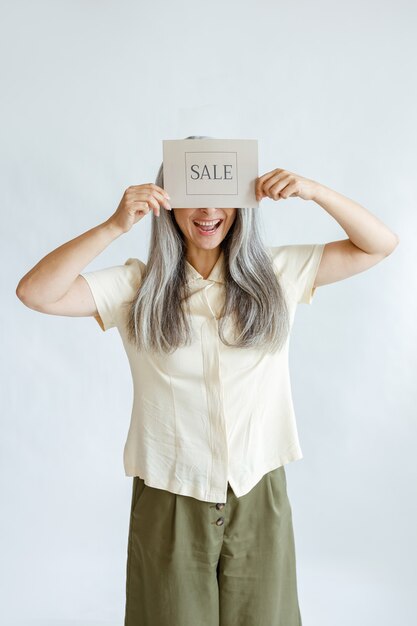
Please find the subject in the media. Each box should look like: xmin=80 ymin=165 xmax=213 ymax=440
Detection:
xmin=255 ymin=168 xmax=318 ymax=202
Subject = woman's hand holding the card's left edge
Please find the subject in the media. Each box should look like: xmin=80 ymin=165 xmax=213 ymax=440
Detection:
xmin=107 ymin=183 xmax=171 ymax=233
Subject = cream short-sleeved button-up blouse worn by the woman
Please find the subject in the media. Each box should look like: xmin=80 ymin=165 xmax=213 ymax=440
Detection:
xmin=81 ymin=244 xmax=325 ymax=503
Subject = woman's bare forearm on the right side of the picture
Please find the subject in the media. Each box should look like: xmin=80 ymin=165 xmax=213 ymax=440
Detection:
xmin=312 ymin=183 xmax=399 ymax=254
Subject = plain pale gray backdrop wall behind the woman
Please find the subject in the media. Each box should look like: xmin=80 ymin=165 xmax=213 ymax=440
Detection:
xmin=0 ymin=0 xmax=417 ymax=626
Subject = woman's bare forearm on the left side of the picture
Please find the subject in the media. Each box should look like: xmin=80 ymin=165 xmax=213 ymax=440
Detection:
xmin=16 ymin=221 xmax=122 ymax=303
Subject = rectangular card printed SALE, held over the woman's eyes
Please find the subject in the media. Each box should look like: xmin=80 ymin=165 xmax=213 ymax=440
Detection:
xmin=162 ymin=139 xmax=259 ymax=209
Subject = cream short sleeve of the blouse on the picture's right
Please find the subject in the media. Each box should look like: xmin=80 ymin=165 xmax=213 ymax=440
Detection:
xmin=269 ymin=243 xmax=326 ymax=304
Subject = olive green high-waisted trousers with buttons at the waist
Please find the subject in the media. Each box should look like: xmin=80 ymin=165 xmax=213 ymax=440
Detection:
xmin=124 ymin=466 xmax=302 ymax=626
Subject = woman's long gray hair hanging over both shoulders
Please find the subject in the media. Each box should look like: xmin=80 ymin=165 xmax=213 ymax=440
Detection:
xmin=127 ymin=135 xmax=289 ymax=353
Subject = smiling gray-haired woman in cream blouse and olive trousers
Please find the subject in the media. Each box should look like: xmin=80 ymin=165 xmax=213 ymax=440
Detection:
xmin=17 ymin=137 xmax=398 ymax=626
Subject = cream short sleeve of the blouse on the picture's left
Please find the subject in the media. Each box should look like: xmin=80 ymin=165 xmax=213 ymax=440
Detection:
xmin=80 ymin=258 xmax=146 ymax=331
